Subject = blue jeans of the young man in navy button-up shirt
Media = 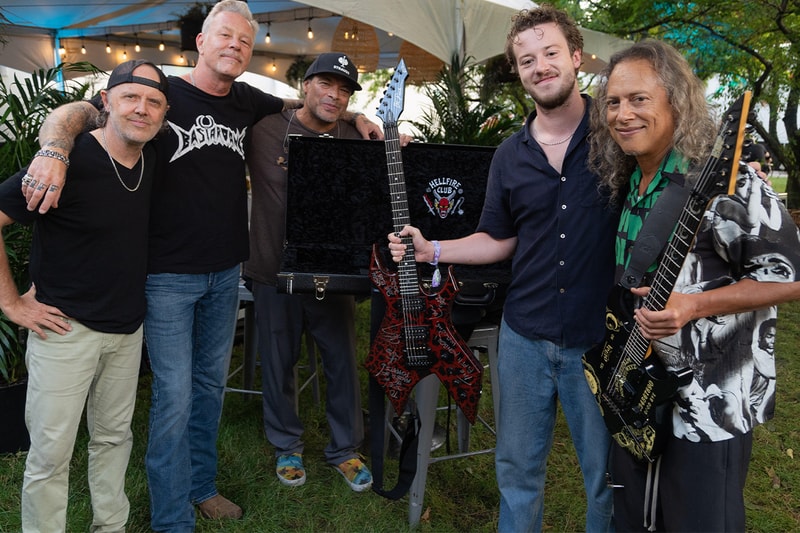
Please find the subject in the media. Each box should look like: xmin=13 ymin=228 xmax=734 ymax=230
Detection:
xmin=495 ymin=321 xmax=613 ymax=533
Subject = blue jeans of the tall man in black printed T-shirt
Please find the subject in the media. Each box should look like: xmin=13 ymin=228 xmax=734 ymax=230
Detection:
xmin=144 ymin=266 xmax=239 ymax=532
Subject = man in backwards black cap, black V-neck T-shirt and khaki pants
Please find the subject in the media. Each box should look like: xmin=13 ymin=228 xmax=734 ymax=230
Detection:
xmin=0 ymin=60 xmax=167 ymax=531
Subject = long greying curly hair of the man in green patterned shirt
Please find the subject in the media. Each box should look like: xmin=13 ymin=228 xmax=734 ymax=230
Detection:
xmin=589 ymin=39 xmax=716 ymax=199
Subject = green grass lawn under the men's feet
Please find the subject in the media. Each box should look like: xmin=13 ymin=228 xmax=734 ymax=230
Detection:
xmin=0 ymin=302 xmax=800 ymax=533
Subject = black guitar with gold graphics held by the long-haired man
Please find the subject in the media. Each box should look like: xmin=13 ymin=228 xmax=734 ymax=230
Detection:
xmin=583 ymin=92 xmax=750 ymax=462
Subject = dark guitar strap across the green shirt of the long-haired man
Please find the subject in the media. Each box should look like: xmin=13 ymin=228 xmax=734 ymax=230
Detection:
xmin=619 ymin=171 xmax=692 ymax=289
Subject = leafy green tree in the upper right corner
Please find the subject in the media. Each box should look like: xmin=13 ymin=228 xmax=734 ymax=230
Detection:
xmin=554 ymin=0 xmax=800 ymax=209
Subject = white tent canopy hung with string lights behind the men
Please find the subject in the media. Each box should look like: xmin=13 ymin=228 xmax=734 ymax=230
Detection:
xmin=0 ymin=0 xmax=626 ymax=79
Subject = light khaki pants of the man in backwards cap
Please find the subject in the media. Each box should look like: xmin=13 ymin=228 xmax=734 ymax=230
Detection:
xmin=22 ymin=321 xmax=142 ymax=533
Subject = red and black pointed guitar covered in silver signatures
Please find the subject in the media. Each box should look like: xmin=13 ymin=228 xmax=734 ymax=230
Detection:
xmin=365 ymin=60 xmax=483 ymax=422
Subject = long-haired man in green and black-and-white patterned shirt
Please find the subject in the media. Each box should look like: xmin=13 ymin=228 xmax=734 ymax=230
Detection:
xmin=589 ymin=41 xmax=800 ymax=531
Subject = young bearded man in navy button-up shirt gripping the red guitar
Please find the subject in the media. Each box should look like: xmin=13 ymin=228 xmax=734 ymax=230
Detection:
xmin=389 ymin=6 xmax=617 ymax=532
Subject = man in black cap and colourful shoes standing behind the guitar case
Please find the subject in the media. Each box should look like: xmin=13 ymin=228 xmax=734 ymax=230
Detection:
xmin=244 ymin=52 xmax=372 ymax=492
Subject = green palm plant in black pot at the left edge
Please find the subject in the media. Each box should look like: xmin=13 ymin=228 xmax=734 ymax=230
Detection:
xmin=0 ymin=62 xmax=99 ymax=453
